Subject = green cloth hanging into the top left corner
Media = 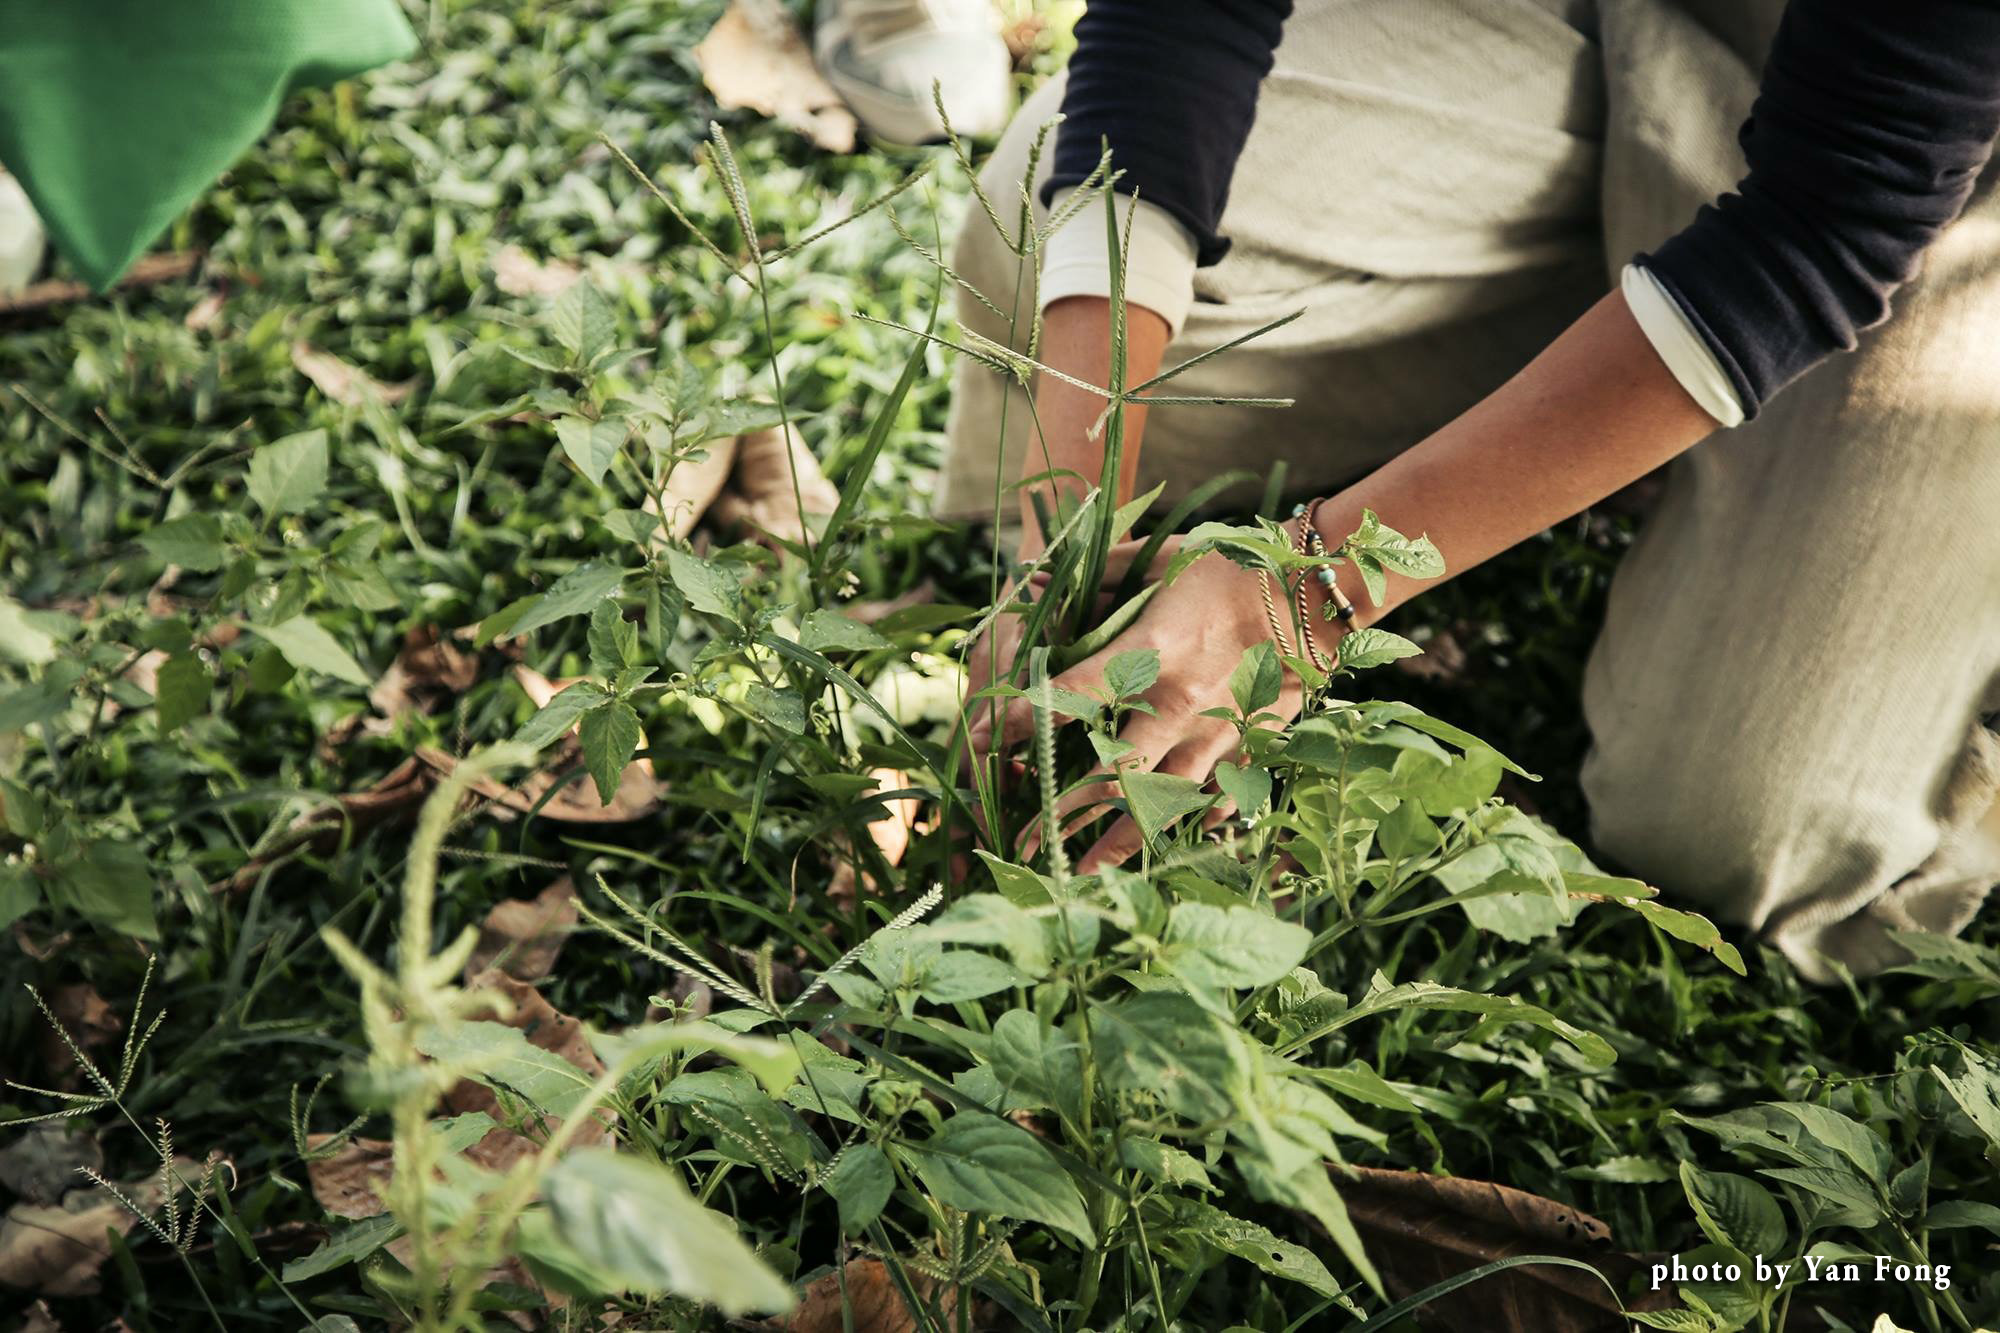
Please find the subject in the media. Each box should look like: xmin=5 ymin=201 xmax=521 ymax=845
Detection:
xmin=0 ymin=0 xmax=416 ymax=290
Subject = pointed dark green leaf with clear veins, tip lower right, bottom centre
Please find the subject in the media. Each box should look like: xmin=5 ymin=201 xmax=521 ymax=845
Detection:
xmin=902 ymin=1111 xmax=1094 ymax=1245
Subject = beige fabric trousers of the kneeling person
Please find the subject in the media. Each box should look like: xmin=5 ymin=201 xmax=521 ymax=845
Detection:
xmin=940 ymin=0 xmax=2000 ymax=979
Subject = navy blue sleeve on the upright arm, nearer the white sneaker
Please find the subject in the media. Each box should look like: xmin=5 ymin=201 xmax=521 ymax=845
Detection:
xmin=1042 ymin=0 xmax=1292 ymax=264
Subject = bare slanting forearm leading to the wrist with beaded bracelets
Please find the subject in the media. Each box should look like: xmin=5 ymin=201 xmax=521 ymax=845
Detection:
xmin=1316 ymin=292 xmax=1716 ymax=624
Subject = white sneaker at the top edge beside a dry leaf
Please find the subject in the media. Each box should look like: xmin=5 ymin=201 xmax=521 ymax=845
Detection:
xmin=812 ymin=0 xmax=1014 ymax=144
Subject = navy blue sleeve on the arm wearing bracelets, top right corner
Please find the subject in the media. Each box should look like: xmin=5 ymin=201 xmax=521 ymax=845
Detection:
xmin=1640 ymin=0 xmax=2000 ymax=416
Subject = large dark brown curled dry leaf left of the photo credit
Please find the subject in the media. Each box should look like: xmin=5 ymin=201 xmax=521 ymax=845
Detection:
xmin=1332 ymin=1167 xmax=1672 ymax=1333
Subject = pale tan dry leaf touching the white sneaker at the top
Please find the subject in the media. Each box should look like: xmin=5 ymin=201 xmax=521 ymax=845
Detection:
xmin=694 ymin=0 xmax=858 ymax=152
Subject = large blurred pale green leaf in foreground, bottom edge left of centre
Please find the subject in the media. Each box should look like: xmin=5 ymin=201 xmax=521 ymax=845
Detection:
xmin=542 ymin=1149 xmax=792 ymax=1315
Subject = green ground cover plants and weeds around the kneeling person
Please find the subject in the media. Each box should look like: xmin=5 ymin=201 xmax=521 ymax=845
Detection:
xmin=0 ymin=0 xmax=2000 ymax=1333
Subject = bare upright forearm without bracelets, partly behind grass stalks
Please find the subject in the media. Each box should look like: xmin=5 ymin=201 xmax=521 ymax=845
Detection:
xmin=1020 ymin=296 xmax=1168 ymax=550
